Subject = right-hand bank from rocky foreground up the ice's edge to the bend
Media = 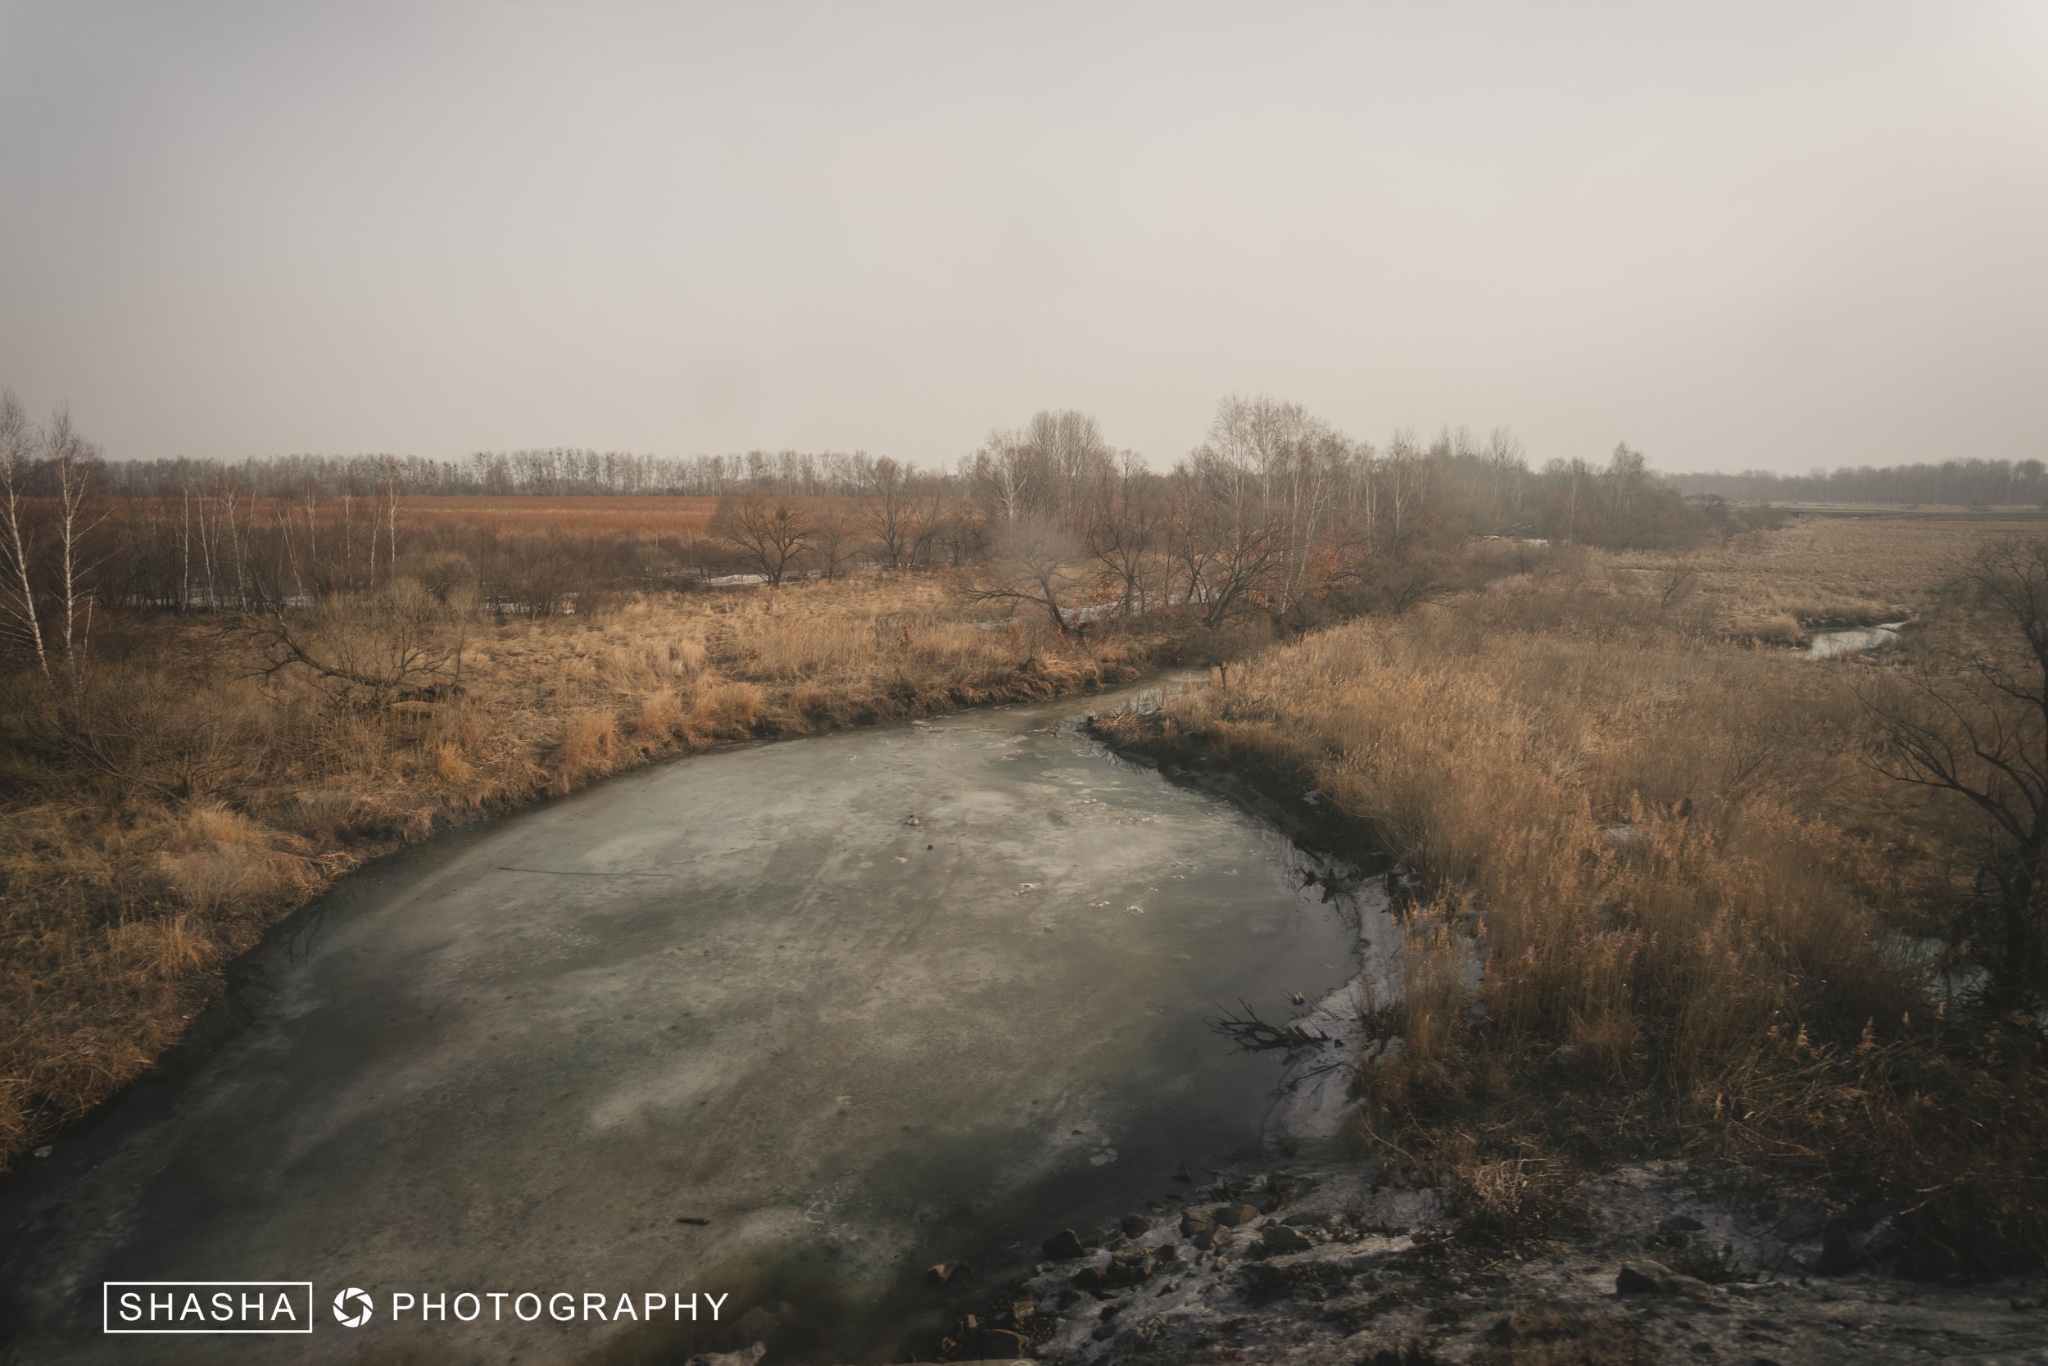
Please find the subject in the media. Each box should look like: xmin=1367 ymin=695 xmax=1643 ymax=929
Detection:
xmin=901 ymin=672 xmax=2048 ymax=1366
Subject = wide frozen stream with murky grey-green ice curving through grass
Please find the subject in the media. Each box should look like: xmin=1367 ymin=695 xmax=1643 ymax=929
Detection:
xmin=0 ymin=684 xmax=1354 ymax=1364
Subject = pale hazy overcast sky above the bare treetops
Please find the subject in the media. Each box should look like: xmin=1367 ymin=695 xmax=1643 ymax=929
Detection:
xmin=0 ymin=0 xmax=2048 ymax=469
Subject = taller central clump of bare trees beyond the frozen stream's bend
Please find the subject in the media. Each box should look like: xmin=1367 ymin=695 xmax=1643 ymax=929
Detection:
xmin=711 ymin=395 xmax=1737 ymax=635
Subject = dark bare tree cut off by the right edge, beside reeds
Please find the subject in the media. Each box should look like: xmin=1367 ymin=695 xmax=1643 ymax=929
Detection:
xmin=1864 ymin=537 xmax=2048 ymax=1006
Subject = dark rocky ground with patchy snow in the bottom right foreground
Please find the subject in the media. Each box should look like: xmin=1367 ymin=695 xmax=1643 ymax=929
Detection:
xmin=921 ymin=1161 xmax=2048 ymax=1366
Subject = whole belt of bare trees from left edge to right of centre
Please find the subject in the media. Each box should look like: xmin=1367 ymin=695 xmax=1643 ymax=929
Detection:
xmin=0 ymin=385 xmax=1761 ymax=670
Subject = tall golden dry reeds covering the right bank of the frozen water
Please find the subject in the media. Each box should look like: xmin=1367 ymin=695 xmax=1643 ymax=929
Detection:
xmin=1114 ymin=526 xmax=2048 ymax=1270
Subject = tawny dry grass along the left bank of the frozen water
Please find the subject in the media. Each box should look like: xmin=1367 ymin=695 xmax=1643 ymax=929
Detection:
xmin=0 ymin=573 xmax=1153 ymax=1163
